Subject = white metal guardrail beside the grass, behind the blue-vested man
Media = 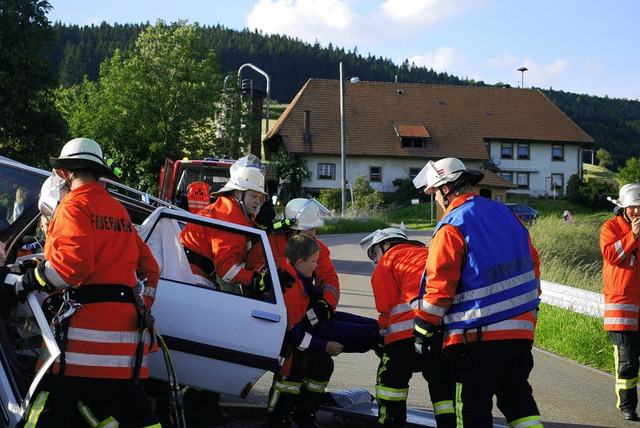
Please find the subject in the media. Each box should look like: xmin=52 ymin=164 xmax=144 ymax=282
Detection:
xmin=540 ymin=280 xmax=604 ymax=318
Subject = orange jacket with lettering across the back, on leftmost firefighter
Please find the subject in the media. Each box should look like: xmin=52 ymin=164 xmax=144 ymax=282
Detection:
xmin=44 ymin=182 xmax=160 ymax=379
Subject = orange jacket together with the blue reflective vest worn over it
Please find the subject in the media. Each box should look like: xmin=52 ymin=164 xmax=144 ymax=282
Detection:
xmin=419 ymin=193 xmax=540 ymax=346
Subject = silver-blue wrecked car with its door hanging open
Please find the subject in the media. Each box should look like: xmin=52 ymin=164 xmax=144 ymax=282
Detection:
xmin=0 ymin=156 xmax=287 ymax=427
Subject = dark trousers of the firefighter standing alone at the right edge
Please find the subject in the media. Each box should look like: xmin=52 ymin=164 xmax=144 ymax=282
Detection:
xmin=609 ymin=331 xmax=640 ymax=412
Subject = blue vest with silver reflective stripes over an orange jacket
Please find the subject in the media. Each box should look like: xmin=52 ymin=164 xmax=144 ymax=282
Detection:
xmin=434 ymin=196 xmax=540 ymax=330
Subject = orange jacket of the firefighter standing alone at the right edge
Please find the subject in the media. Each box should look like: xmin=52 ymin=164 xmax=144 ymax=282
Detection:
xmin=600 ymin=215 xmax=640 ymax=331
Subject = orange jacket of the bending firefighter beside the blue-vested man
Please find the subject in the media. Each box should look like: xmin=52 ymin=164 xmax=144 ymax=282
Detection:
xmin=371 ymin=243 xmax=429 ymax=344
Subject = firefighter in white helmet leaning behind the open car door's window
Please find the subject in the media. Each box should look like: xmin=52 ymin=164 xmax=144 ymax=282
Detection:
xmin=180 ymin=155 xmax=268 ymax=294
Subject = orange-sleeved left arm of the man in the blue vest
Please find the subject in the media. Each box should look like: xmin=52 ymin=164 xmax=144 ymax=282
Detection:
xmin=418 ymin=225 xmax=467 ymax=325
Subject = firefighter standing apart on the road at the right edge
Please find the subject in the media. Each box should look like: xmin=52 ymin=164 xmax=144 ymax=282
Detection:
xmin=600 ymin=183 xmax=640 ymax=421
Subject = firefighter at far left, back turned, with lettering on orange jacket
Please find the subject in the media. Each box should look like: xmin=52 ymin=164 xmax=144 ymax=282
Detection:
xmin=16 ymin=138 xmax=160 ymax=427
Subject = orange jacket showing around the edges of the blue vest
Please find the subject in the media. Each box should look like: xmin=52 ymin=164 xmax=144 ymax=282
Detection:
xmin=419 ymin=193 xmax=540 ymax=347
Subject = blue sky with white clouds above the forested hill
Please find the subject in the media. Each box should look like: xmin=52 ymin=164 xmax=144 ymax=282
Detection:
xmin=48 ymin=0 xmax=640 ymax=100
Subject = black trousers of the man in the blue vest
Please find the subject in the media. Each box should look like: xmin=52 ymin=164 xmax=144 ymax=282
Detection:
xmin=445 ymin=339 xmax=542 ymax=428
